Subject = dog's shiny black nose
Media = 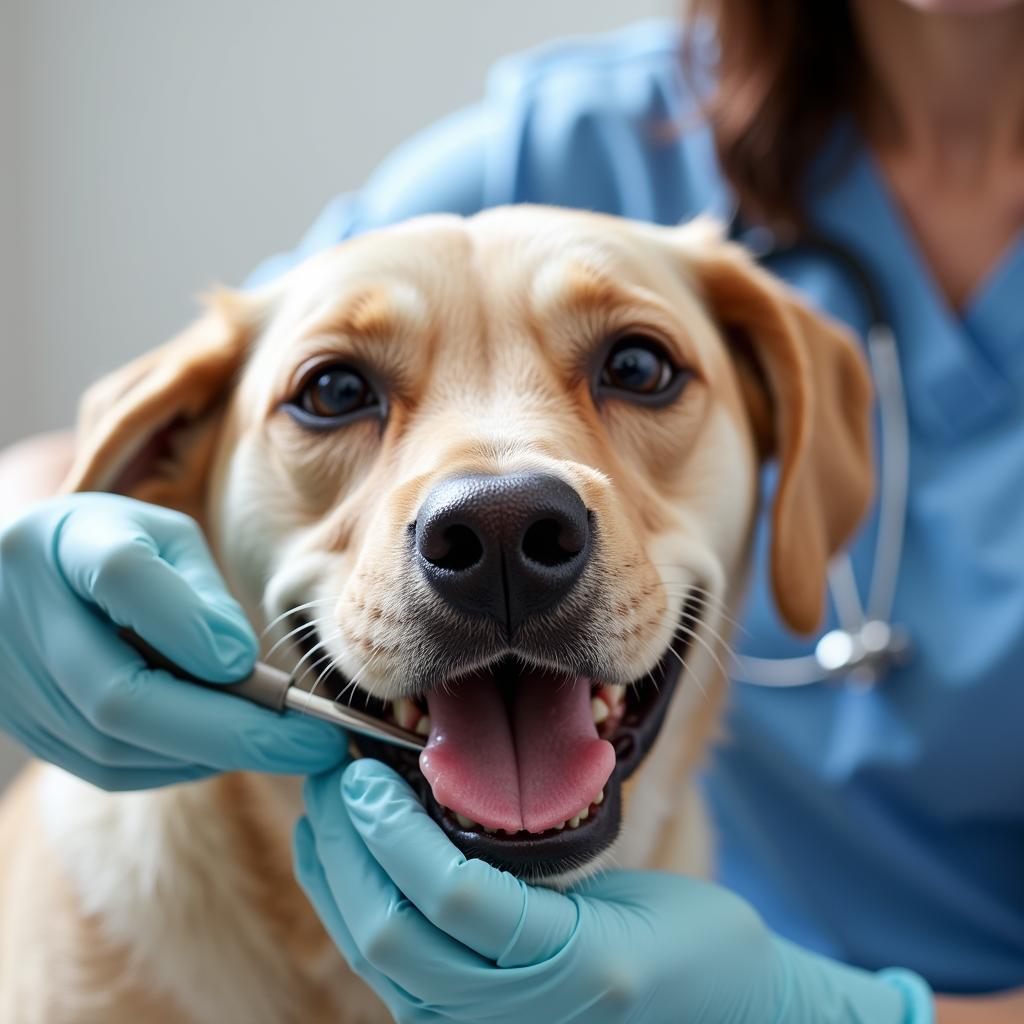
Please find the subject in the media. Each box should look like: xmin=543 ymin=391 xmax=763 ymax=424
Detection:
xmin=416 ymin=473 xmax=591 ymax=635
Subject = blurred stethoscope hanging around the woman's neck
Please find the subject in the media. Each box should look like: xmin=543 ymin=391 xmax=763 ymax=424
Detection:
xmin=729 ymin=213 xmax=911 ymax=687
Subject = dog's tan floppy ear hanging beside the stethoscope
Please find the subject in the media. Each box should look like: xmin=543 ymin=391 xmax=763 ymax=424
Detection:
xmin=694 ymin=228 xmax=874 ymax=633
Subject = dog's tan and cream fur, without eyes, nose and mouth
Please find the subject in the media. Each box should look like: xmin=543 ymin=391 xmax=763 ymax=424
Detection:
xmin=0 ymin=208 xmax=871 ymax=1024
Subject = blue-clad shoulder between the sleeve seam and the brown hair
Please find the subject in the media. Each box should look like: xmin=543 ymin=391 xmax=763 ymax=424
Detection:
xmin=487 ymin=18 xmax=720 ymax=222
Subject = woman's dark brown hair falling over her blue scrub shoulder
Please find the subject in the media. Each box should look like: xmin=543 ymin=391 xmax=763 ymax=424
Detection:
xmin=683 ymin=0 xmax=863 ymax=223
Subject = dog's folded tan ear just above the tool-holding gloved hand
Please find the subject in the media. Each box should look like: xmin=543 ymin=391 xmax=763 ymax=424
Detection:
xmin=63 ymin=290 xmax=261 ymax=513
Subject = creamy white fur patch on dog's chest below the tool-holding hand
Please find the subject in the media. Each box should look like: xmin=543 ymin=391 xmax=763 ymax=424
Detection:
xmin=39 ymin=767 xmax=303 ymax=1024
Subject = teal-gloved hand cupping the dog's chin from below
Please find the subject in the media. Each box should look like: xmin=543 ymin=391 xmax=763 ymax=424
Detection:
xmin=296 ymin=760 xmax=933 ymax=1024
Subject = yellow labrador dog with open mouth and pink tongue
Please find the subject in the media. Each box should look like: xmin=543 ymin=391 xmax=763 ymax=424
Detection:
xmin=0 ymin=207 xmax=872 ymax=1024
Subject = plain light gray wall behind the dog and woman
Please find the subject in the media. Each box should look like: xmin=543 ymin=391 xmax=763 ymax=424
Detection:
xmin=0 ymin=0 xmax=681 ymax=785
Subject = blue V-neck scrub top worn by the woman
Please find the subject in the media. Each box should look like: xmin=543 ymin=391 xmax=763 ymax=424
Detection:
xmin=250 ymin=22 xmax=1024 ymax=992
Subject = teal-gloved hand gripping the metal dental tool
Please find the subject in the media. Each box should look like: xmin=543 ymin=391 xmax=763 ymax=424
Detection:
xmin=0 ymin=495 xmax=347 ymax=790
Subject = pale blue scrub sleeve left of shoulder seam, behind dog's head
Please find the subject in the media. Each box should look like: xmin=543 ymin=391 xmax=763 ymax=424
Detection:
xmin=244 ymin=101 xmax=499 ymax=288
